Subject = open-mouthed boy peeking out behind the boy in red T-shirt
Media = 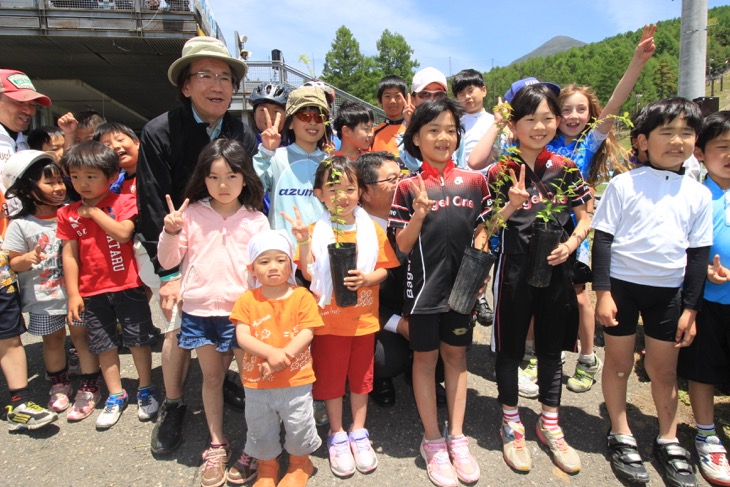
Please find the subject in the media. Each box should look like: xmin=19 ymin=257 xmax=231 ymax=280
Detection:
xmin=93 ymin=122 xmax=139 ymax=194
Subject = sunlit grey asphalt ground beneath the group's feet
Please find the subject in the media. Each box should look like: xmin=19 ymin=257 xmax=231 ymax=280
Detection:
xmin=0 ymin=304 xmax=708 ymax=487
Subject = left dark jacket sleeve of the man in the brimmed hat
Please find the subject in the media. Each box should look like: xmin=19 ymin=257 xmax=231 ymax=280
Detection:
xmin=137 ymin=114 xmax=177 ymax=276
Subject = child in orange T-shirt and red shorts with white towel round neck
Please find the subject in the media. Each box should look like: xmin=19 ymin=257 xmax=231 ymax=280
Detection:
xmin=282 ymin=156 xmax=399 ymax=477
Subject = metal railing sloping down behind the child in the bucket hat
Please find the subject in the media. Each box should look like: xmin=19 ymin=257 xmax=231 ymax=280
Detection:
xmin=242 ymin=61 xmax=385 ymax=124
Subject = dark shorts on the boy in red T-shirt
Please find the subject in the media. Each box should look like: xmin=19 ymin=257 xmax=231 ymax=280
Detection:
xmin=84 ymin=286 xmax=155 ymax=355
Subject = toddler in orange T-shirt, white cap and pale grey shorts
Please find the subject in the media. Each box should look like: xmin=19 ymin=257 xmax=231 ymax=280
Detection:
xmin=231 ymin=230 xmax=324 ymax=487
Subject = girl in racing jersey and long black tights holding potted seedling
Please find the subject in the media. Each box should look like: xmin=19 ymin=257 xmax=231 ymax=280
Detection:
xmin=487 ymin=84 xmax=591 ymax=473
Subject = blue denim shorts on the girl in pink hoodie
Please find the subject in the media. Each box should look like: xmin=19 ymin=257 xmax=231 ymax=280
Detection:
xmin=177 ymin=311 xmax=236 ymax=353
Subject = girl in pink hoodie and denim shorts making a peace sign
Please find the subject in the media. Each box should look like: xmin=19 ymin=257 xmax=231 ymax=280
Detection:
xmin=157 ymin=139 xmax=269 ymax=479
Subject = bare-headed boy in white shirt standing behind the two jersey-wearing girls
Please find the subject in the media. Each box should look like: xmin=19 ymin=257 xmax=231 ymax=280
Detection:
xmin=451 ymin=69 xmax=494 ymax=167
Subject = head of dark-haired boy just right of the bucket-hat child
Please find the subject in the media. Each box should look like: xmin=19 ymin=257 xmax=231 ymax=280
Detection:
xmin=332 ymin=101 xmax=375 ymax=161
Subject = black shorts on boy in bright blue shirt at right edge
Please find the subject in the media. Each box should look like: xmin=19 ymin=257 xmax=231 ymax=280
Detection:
xmin=677 ymin=300 xmax=730 ymax=385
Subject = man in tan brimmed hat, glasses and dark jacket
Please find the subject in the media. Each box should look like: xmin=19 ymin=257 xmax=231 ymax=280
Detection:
xmin=137 ymin=36 xmax=256 ymax=476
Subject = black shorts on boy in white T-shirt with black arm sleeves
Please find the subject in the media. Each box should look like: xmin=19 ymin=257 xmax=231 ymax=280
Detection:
xmin=603 ymin=278 xmax=682 ymax=342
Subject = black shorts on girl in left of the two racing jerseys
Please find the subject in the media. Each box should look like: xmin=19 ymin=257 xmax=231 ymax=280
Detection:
xmin=408 ymin=311 xmax=474 ymax=352
